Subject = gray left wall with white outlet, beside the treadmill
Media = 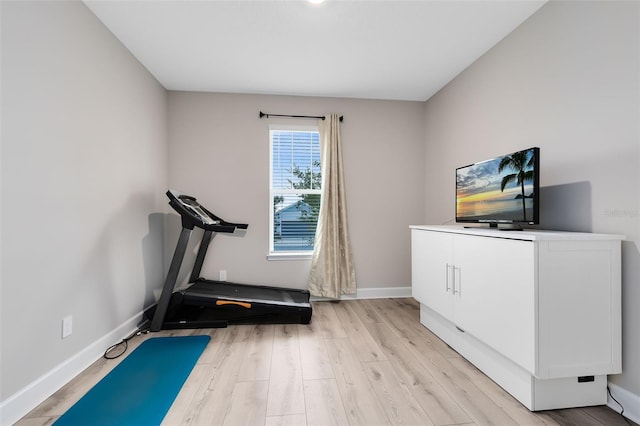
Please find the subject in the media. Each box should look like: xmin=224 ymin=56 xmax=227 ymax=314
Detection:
xmin=0 ymin=1 xmax=167 ymax=401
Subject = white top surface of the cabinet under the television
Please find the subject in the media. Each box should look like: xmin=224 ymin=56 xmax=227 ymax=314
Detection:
xmin=409 ymin=225 xmax=625 ymax=241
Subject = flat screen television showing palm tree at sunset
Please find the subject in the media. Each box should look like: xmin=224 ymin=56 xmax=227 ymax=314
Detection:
xmin=456 ymin=148 xmax=540 ymax=227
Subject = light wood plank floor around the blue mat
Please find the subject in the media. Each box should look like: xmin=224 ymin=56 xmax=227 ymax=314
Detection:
xmin=17 ymin=299 xmax=630 ymax=426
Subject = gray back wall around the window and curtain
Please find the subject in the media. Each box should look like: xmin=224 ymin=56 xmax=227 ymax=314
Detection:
xmin=166 ymin=92 xmax=424 ymax=288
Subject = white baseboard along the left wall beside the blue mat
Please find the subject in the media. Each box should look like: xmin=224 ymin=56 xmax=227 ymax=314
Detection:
xmin=0 ymin=313 xmax=143 ymax=426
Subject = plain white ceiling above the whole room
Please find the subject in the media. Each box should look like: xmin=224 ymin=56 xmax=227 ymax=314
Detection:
xmin=84 ymin=0 xmax=545 ymax=101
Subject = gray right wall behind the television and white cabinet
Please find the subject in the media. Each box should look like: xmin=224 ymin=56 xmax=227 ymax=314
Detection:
xmin=425 ymin=1 xmax=640 ymax=395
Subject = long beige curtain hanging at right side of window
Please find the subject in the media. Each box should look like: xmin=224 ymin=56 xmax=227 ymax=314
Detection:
xmin=309 ymin=114 xmax=356 ymax=299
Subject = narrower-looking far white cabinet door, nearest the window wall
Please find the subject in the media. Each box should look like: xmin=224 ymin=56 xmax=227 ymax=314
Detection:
xmin=411 ymin=229 xmax=453 ymax=320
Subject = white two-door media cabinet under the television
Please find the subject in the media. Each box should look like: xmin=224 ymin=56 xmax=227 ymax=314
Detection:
xmin=410 ymin=226 xmax=624 ymax=411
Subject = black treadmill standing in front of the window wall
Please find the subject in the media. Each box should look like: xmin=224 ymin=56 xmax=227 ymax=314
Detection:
xmin=145 ymin=190 xmax=312 ymax=331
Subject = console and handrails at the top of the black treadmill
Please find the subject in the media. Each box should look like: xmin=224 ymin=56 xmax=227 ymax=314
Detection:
xmin=167 ymin=190 xmax=249 ymax=233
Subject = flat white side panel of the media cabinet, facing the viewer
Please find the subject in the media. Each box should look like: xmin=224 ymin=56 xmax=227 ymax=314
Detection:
xmin=538 ymin=240 xmax=622 ymax=378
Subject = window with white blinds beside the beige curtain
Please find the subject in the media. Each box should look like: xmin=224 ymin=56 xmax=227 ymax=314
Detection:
xmin=269 ymin=126 xmax=321 ymax=255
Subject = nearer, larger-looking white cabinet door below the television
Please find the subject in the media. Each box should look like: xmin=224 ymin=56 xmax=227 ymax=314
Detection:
xmin=454 ymin=235 xmax=537 ymax=373
